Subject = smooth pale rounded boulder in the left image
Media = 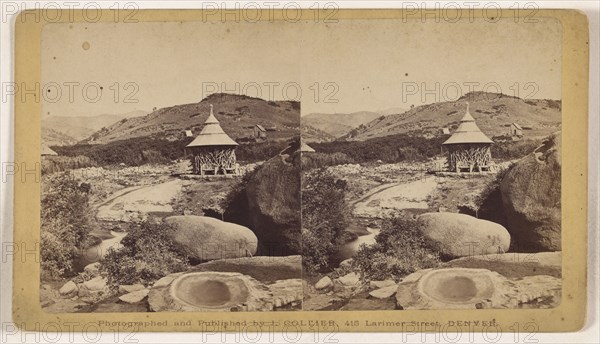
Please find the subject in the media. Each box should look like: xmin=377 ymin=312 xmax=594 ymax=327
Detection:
xmin=164 ymin=215 xmax=258 ymax=261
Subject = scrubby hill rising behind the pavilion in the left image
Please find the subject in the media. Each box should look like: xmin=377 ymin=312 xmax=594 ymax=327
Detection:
xmin=83 ymin=93 xmax=300 ymax=144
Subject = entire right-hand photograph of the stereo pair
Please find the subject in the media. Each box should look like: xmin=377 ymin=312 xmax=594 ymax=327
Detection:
xmin=300 ymin=17 xmax=563 ymax=311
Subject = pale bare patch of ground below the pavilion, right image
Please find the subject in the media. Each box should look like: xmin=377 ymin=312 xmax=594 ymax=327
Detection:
xmin=353 ymin=176 xmax=438 ymax=217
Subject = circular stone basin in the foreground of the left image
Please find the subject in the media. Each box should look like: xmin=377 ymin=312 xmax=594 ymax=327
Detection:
xmin=171 ymin=272 xmax=249 ymax=310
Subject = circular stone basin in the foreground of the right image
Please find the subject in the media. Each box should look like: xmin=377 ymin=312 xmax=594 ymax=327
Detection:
xmin=419 ymin=269 xmax=494 ymax=304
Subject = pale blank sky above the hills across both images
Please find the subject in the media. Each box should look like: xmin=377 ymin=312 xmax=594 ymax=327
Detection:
xmin=42 ymin=18 xmax=562 ymax=116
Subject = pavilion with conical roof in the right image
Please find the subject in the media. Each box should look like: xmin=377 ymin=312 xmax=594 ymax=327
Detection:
xmin=443 ymin=103 xmax=494 ymax=173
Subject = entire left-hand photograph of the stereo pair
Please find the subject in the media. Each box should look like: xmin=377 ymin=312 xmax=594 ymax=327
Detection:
xmin=39 ymin=22 xmax=303 ymax=313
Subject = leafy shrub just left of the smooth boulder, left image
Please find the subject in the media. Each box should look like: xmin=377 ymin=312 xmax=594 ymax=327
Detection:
xmin=101 ymin=222 xmax=189 ymax=288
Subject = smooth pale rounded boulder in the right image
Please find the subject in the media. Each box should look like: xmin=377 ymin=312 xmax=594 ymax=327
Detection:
xmin=418 ymin=213 xmax=510 ymax=257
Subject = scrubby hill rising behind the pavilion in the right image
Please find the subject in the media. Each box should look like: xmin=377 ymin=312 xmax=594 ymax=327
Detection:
xmin=344 ymin=92 xmax=561 ymax=140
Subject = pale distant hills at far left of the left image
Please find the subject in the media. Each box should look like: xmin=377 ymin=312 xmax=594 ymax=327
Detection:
xmin=42 ymin=111 xmax=147 ymax=145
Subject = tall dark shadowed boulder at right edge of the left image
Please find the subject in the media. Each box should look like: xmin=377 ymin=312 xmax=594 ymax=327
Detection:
xmin=224 ymin=145 xmax=301 ymax=256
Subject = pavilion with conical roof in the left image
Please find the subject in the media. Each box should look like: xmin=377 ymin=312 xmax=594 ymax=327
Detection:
xmin=186 ymin=104 xmax=238 ymax=175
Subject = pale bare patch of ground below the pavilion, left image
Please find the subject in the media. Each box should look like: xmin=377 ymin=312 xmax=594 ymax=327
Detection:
xmin=96 ymin=179 xmax=183 ymax=222
